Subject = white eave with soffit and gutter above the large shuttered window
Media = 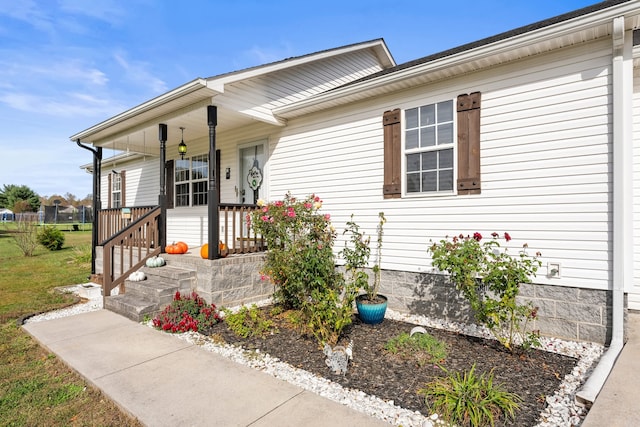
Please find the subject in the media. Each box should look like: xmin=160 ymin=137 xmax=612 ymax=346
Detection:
xmin=274 ymin=0 xmax=640 ymax=119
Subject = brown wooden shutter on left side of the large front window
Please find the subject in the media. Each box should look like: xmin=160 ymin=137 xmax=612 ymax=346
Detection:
xmin=382 ymin=108 xmax=402 ymax=199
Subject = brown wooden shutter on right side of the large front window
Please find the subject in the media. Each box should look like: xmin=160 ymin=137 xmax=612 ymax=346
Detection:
xmin=457 ymin=92 xmax=480 ymax=194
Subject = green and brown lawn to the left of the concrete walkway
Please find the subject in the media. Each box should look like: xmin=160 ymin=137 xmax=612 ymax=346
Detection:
xmin=0 ymin=224 xmax=140 ymax=426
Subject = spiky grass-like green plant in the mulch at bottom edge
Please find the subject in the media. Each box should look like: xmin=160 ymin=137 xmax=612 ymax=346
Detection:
xmin=418 ymin=364 xmax=522 ymax=427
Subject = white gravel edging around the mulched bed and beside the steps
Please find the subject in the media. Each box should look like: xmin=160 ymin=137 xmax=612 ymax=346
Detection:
xmin=25 ymin=284 xmax=604 ymax=427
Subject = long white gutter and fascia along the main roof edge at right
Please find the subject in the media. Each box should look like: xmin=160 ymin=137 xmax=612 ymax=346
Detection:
xmin=273 ymin=2 xmax=640 ymax=116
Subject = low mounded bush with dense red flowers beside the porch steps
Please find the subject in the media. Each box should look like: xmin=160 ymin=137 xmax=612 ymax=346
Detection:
xmin=153 ymin=291 xmax=221 ymax=333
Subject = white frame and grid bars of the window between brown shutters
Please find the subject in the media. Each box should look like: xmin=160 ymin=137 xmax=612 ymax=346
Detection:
xmin=401 ymin=98 xmax=458 ymax=197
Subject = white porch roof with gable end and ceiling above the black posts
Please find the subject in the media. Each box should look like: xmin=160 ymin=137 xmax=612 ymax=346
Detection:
xmin=70 ymin=39 xmax=396 ymax=154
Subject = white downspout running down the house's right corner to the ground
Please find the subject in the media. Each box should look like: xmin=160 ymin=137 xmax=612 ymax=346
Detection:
xmin=576 ymin=16 xmax=633 ymax=404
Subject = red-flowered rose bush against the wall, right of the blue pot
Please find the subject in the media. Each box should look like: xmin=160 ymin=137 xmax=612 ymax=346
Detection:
xmin=429 ymin=232 xmax=541 ymax=351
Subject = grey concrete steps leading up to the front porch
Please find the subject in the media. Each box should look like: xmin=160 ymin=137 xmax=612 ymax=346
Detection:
xmin=105 ymin=265 xmax=196 ymax=322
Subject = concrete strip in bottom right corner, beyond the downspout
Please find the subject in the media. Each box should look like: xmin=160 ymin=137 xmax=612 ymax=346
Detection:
xmin=582 ymin=312 xmax=640 ymax=427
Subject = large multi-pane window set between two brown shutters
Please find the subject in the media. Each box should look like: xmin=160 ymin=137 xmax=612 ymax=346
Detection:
xmin=404 ymin=100 xmax=454 ymax=194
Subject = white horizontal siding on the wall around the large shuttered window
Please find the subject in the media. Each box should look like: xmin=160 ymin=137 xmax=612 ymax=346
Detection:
xmin=269 ymin=38 xmax=612 ymax=289
